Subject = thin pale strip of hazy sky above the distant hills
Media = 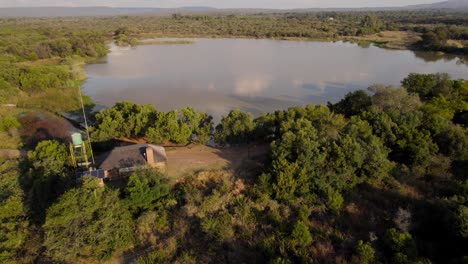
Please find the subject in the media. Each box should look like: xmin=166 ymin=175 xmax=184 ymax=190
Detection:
xmin=0 ymin=0 xmax=444 ymax=8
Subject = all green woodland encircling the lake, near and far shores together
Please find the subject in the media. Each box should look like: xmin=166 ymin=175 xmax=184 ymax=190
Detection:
xmin=0 ymin=8 xmax=468 ymax=264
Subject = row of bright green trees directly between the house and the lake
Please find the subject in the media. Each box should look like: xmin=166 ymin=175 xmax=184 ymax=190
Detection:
xmin=91 ymin=102 xmax=213 ymax=144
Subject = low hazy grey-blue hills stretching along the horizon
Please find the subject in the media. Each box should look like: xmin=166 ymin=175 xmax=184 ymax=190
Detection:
xmin=0 ymin=0 xmax=468 ymax=17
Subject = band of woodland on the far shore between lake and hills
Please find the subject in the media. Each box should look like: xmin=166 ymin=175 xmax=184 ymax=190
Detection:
xmin=0 ymin=10 xmax=468 ymax=55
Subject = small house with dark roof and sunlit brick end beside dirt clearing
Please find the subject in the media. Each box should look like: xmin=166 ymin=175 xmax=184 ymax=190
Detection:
xmin=98 ymin=144 xmax=167 ymax=178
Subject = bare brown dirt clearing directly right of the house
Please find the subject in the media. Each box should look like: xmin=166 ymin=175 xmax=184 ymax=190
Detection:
xmin=166 ymin=145 xmax=269 ymax=178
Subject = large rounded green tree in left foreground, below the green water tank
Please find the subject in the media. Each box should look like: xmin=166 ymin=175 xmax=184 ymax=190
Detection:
xmin=43 ymin=177 xmax=133 ymax=262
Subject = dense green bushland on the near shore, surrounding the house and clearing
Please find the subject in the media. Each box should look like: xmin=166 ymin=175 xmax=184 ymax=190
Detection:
xmin=0 ymin=71 xmax=468 ymax=263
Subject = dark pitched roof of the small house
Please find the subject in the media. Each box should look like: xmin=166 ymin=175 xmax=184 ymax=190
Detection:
xmin=98 ymin=144 xmax=167 ymax=170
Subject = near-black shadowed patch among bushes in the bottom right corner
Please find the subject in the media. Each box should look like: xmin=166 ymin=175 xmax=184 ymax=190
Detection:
xmin=336 ymin=184 xmax=468 ymax=263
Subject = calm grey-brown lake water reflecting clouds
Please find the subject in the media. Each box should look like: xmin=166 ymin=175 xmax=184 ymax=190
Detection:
xmin=83 ymin=39 xmax=468 ymax=120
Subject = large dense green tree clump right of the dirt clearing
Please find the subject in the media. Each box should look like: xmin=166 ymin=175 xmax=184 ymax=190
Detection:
xmin=271 ymin=108 xmax=393 ymax=204
